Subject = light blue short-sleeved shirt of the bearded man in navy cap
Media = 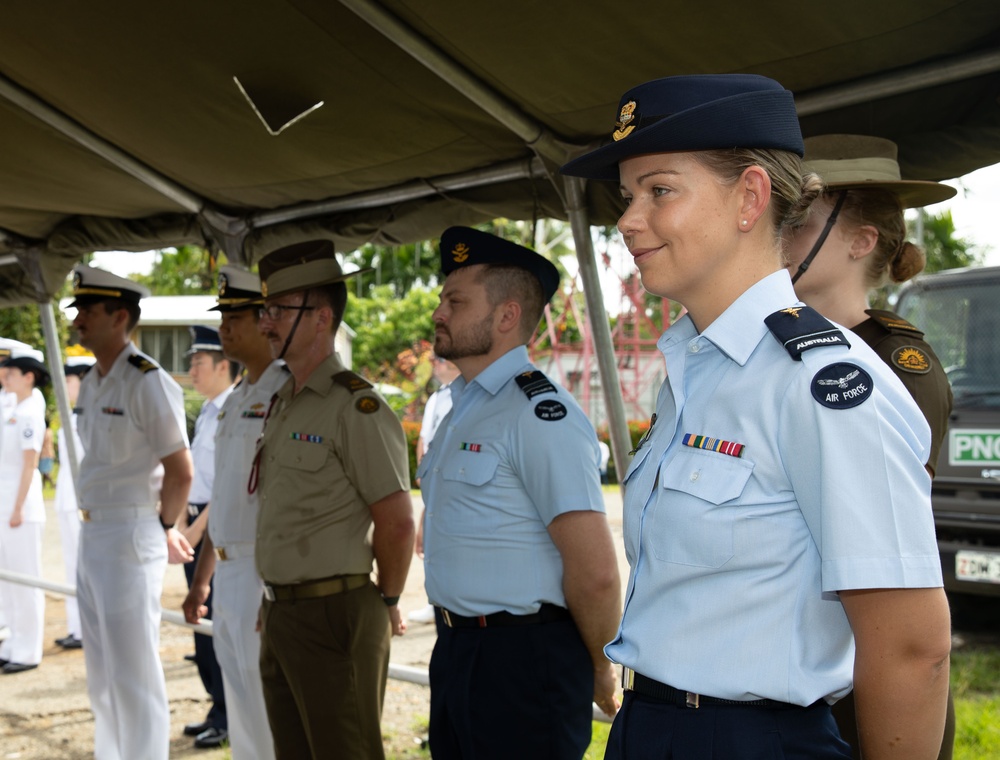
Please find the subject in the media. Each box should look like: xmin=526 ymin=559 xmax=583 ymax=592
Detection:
xmin=417 ymin=346 xmax=604 ymax=616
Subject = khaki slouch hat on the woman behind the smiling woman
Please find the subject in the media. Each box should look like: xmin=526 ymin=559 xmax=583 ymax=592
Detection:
xmin=805 ymin=135 xmax=958 ymax=208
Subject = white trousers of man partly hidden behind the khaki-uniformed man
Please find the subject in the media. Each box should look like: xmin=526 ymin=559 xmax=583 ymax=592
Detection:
xmin=212 ymin=556 xmax=274 ymax=760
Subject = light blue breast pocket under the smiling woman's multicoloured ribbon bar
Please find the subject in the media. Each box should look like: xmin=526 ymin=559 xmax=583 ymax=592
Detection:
xmin=649 ymin=449 xmax=753 ymax=568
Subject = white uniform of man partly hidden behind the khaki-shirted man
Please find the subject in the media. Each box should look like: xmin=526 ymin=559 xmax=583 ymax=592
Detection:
xmin=208 ymin=361 xmax=288 ymax=760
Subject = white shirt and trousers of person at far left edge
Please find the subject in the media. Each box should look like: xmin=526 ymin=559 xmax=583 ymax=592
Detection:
xmin=0 ymin=394 xmax=45 ymax=665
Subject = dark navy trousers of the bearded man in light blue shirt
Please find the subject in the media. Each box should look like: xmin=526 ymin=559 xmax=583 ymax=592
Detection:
xmin=430 ymin=614 xmax=594 ymax=760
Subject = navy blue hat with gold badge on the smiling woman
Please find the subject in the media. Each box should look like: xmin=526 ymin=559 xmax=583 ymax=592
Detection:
xmin=560 ymin=74 xmax=804 ymax=182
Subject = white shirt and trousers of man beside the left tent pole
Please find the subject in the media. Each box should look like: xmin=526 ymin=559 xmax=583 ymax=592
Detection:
xmin=77 ymin=343 xmax=188 ymax=760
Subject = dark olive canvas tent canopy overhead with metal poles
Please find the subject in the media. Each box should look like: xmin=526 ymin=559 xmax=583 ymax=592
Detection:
xmin=0 ymin=0 xmax=1000 ymax=306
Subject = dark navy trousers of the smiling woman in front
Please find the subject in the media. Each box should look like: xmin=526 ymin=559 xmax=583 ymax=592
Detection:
xmin=604 ymin=691 xmax=851 ymax=760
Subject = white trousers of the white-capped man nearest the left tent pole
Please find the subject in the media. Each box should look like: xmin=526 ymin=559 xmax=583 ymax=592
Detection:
xmin=77 ymin=513 xmax=170 ymax=760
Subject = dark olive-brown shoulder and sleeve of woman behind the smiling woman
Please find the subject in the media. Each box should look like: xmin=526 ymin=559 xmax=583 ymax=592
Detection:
xmin=851 ymin=309 xmax=952 ymax=477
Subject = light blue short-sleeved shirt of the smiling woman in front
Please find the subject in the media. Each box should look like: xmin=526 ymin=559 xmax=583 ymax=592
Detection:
xmin=605 ymin=270 xmax=941 ymax=705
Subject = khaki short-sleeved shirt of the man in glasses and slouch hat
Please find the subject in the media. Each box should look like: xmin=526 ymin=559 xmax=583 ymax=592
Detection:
xmin=256 ymin=356 xmax=410 ymax=584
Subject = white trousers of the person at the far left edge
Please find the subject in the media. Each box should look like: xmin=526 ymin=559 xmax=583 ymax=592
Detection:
xmin=0 ymin=517 xmax=45 ymax=665
